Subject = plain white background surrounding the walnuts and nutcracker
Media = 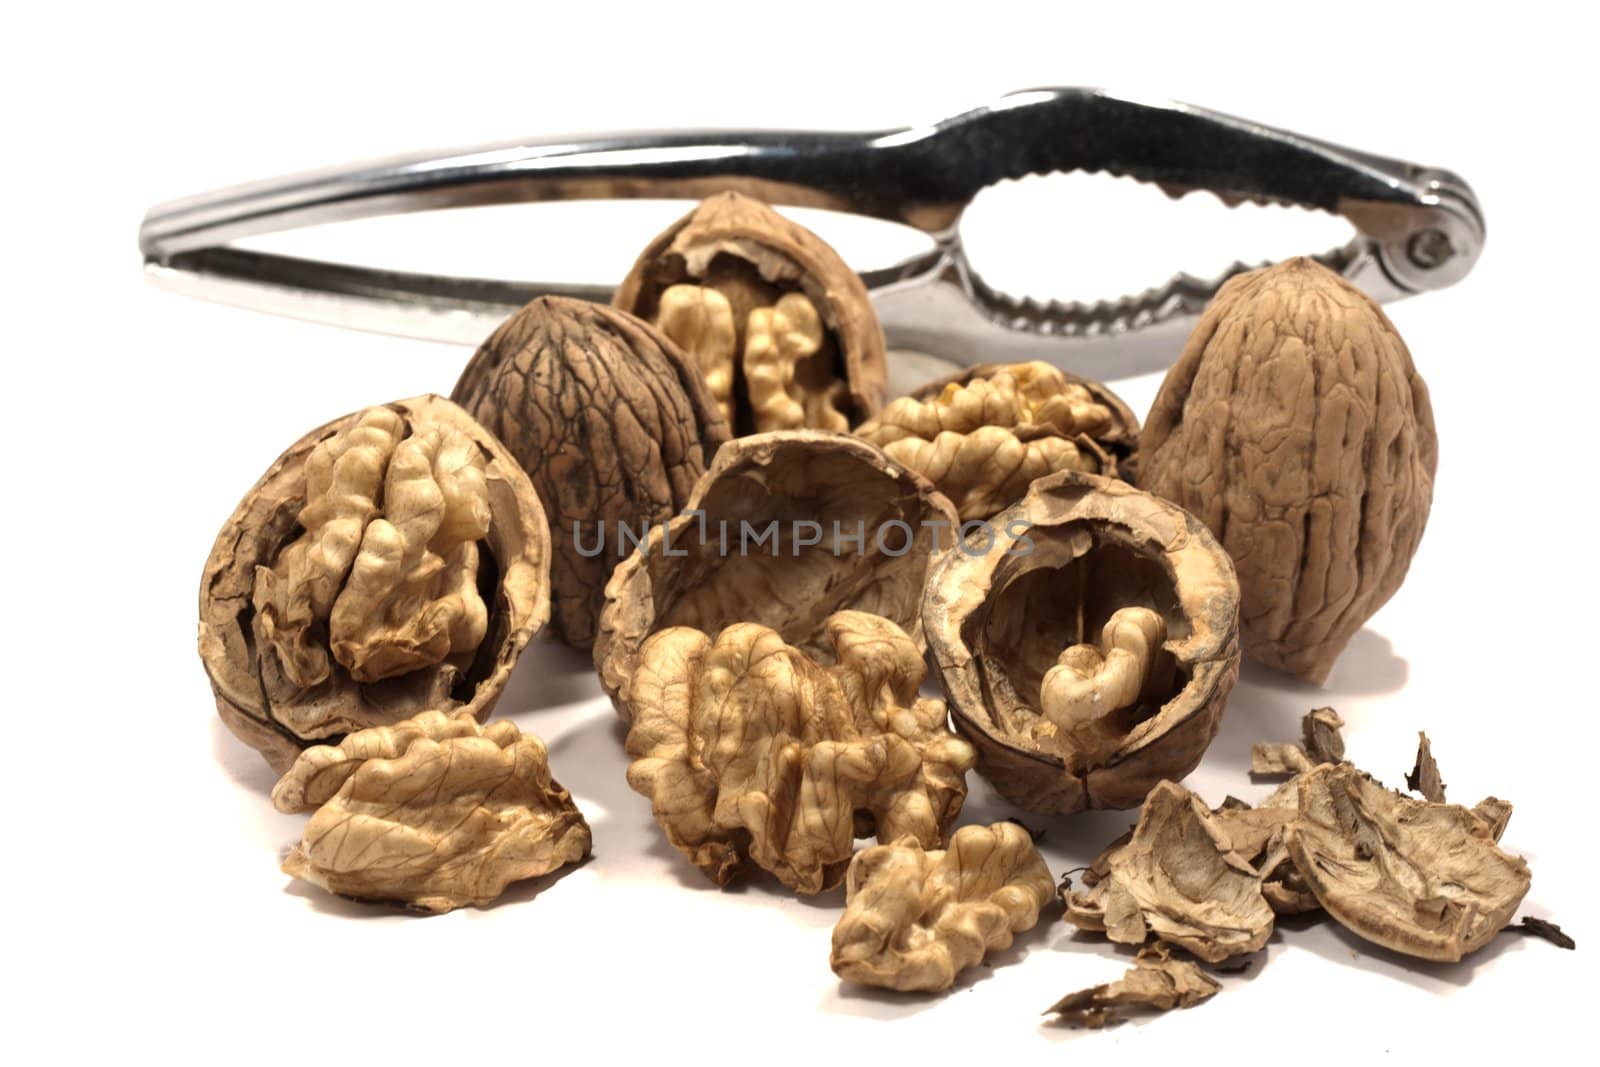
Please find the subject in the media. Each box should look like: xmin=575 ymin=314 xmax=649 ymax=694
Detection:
xmin=0 ymin=2 xmax=1597 ymax=1064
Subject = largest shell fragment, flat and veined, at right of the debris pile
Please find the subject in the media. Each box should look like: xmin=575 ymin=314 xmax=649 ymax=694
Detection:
xmin=1286 ymin=763 xmax=1531 ymax=961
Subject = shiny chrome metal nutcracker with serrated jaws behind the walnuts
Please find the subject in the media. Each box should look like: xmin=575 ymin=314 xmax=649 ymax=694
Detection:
xmin=139 ymin=90 xmax=1485 ymax=379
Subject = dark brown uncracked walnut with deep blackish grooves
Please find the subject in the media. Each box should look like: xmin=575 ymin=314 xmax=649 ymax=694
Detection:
xmin=451 ymin=296 xmax=728 ymax=648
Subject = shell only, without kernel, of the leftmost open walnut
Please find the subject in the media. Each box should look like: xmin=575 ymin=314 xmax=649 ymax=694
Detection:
xmin=200 ymin=395 xmax=550 ymax=774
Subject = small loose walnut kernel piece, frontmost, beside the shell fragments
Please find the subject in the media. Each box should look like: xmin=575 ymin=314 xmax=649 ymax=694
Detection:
xmin=829 ymin=822 xmax=1056 ymax=992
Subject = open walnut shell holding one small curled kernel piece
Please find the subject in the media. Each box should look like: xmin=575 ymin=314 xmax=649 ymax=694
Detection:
xmin=923 ymin=470 xmax=1238 ymax=813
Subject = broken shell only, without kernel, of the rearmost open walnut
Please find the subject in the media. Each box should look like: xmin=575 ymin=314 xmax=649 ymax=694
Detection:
xmin=613 ymin=192 xmax=888 ymax=435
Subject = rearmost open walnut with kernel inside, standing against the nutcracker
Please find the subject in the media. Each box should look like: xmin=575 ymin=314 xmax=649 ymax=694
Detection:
xmin=614 ymin=192 xmax=888 ymax=435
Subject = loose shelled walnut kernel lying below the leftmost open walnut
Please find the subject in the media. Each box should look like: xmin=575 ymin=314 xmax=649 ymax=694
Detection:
xmin=272 ymin=713 xmax=590 ymax=912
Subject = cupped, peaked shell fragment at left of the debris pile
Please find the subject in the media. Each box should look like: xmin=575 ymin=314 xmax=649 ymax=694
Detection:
xmin=1067 ymin=782 xmax=1274 ymax=963
